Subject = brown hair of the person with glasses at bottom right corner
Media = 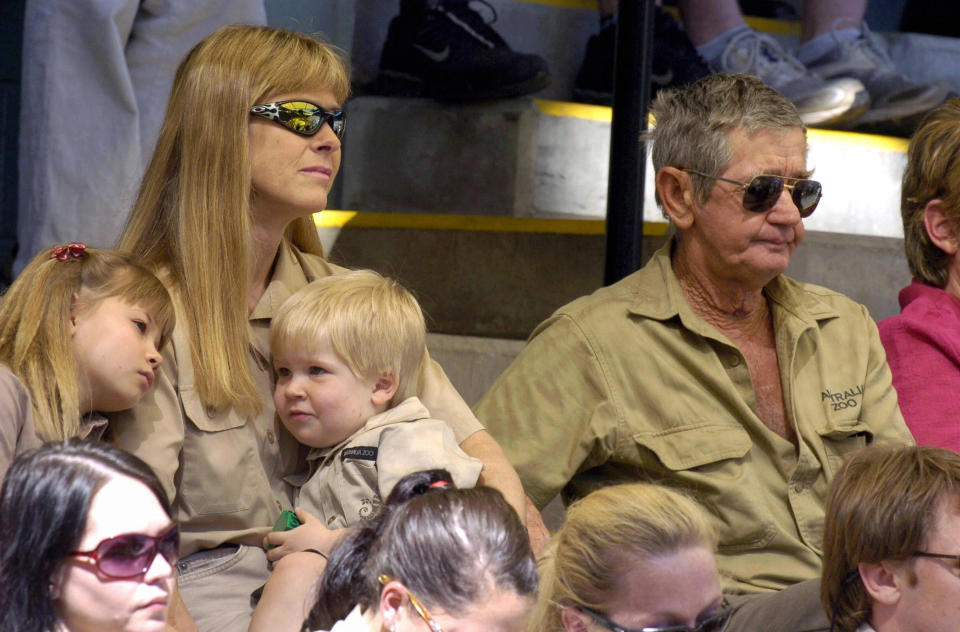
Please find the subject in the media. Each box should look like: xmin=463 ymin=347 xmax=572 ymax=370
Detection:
xmin=820 ymin=446 xmax=960 ymax=632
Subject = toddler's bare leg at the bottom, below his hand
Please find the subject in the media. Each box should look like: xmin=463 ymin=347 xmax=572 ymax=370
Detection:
xmin=249 ymin=552 xmax=327 ymax=632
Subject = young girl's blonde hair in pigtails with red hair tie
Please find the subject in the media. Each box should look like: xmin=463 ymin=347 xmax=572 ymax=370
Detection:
xmin=0 ymin=248 xmax=174 ymax=441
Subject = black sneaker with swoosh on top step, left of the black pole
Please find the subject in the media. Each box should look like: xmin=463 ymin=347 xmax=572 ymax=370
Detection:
xmin=374 ymin=0 xmax=550 ymax=101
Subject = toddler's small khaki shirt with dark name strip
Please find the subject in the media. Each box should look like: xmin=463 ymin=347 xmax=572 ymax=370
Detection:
xmin=288 ymin=397 xmax=483 ymax=529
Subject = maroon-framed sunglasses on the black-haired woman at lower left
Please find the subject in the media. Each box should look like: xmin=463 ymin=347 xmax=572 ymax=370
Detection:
xmin=70 ymin=525 xmax=180 ymax=579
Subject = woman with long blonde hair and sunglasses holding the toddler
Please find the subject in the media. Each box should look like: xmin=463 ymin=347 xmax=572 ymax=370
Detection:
xmin=116 ymin=25 xmax=523 ymax=632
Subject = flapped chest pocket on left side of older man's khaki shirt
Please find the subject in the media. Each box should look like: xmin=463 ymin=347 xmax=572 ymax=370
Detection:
xmin=634 ymin=423 xmax=777 ymax=553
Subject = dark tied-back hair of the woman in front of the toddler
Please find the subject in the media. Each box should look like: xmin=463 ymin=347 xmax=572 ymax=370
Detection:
xmin=303 ymin=470 xmax=537 ymax=630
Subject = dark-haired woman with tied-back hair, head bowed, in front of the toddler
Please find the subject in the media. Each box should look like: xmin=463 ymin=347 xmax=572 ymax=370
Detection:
xmin=295 ymin=470 xmax=537 ymax=632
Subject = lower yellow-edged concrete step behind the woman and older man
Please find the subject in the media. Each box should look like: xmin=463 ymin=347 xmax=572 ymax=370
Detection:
xmin=316 ymin=211 xmax=910 ymax=340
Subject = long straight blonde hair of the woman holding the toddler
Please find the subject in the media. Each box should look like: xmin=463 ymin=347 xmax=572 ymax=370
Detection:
xmin=120 ymin=25 xmax=350 ymax=414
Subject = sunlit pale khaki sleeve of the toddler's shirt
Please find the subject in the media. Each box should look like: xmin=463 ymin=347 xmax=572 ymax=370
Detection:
xmin=377 ymin=419 xmax=483 ymax=500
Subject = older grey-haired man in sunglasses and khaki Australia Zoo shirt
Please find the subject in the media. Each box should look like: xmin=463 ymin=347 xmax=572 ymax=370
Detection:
xmin=477 ymin=75 xmax=911 ymax=612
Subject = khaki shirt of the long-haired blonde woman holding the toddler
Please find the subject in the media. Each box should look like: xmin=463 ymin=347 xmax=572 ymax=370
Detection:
xmin=111 ymin=241 xmax=482 ymax=556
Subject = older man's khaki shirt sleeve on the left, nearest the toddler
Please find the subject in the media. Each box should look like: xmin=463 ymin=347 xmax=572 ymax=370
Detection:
xmin=476 ymin=315 xmax=619 ymax=508
